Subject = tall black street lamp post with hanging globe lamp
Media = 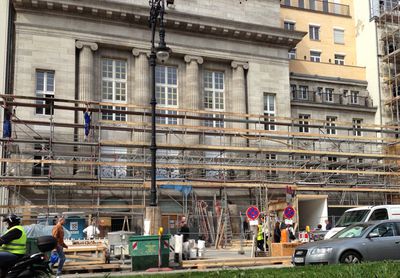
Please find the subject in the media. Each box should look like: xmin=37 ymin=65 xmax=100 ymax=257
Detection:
xmin=149 ymin=0 xmax=173 ymax=207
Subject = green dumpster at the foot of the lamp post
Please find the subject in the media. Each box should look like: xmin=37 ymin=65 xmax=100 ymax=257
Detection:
xmin=129 ymin=235 xmax=170 ymax=270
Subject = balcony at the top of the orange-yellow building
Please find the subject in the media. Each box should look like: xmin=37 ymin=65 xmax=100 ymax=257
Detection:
xmin=281 ymin=0 xmax=350 ymax=16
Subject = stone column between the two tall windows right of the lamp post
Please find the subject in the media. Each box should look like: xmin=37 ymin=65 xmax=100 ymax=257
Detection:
xmin=184 ymin=55 xmax=203 ymax=145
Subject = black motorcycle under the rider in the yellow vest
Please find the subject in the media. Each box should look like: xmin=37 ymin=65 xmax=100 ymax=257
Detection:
xmin=6 ymin=236 xmax=57 ymax=278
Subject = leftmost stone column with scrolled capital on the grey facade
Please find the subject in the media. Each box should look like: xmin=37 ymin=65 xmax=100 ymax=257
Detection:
xmin=75 ymin=41 xmax=98 ymax=177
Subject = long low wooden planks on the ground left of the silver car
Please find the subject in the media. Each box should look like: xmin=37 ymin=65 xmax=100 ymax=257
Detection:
xmin=182 ymin=256 xmax=291 ymax=269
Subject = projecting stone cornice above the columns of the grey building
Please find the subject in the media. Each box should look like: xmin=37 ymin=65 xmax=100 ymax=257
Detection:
xmin=12 ymin=0 xmax=306 ymax=48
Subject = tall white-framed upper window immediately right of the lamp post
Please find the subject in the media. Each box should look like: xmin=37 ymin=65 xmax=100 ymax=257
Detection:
xmin=156 ymin=66 xmax=178 ymax=125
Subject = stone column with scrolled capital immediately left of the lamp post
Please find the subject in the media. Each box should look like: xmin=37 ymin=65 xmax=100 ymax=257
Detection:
xmin=132 ymin=48 xmax=151 ymax=144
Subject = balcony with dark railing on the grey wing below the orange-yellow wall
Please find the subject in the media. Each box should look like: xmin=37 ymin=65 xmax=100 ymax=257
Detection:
xmin=291 ymin=90 xmax=373 ymax=108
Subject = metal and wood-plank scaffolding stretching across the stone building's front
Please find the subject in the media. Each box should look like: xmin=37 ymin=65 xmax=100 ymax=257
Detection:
xmin=0 ymin=95 xmax=400 ymax=222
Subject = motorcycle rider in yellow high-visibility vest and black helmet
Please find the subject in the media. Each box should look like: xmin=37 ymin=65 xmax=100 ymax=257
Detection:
xmin=0 ymin=214 xmax=27 ymax=278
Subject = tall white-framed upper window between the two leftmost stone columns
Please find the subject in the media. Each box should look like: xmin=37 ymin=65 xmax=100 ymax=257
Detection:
xmin=101 ymin=58 xmax=127 ymax=121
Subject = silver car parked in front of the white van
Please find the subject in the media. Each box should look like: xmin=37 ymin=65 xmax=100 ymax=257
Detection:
xmin=292 ymin=220 xmax=400 ymax=265
